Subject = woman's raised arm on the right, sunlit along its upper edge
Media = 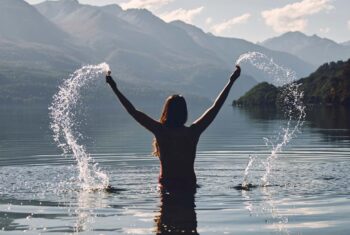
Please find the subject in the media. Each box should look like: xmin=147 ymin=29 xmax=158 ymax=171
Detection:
xmin=191 ymin=65 xmax=241 ymax=134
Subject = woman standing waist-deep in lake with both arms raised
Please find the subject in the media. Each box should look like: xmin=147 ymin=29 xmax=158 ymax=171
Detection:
xmin=106 ymin=65 xmax=241 ymax=188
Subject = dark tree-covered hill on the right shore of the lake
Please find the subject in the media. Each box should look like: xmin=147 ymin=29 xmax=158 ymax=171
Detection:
xmin=233 ymin=59 xmax=350 ymax=106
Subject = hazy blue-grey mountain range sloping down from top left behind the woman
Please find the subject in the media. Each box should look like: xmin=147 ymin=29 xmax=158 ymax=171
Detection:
xmin=0 ymin=0 xmax=350 ymax=102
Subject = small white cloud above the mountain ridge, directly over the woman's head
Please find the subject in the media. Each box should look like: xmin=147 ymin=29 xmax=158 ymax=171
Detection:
xmin=160 ymin=6 xmax=204 ymax=24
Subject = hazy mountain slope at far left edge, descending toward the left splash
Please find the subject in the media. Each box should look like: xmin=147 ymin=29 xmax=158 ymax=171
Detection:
xmin=0 ymin=0 xmax=89 ymax=70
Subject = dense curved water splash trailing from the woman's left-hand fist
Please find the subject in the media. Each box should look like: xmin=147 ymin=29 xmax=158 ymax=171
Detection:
xmin=49 ymin=63 xmax=109 ymax=190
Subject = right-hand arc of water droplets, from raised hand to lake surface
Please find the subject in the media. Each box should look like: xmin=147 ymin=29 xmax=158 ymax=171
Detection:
xmin=236 ymin=52 xmax=306 ymax=187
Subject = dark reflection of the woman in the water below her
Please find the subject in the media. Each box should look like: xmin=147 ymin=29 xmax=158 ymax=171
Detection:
xmin=154 ymin=190 xmax=198 ymax=235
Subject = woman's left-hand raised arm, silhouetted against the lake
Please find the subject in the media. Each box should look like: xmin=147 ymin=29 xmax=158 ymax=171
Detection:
xmin=106 ymin=72 xmax=161 ymax=134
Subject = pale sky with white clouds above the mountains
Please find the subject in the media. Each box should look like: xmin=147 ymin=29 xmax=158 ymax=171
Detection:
xmin=26 ymin=0 xmax=350 ymax=42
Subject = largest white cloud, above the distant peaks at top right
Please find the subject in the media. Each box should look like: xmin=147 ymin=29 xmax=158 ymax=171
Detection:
xmin=261 ymin=0 xmax=334 ymax=33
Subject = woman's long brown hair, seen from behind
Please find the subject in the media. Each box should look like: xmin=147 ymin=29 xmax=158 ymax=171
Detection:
xmin=153 ymin=95 xmax=187 ymax=157
